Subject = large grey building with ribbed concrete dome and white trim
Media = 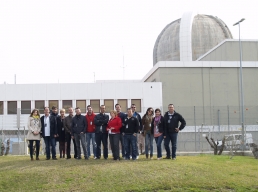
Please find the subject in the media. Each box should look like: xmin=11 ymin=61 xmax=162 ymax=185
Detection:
xmin=143 ymin=12 xmax=258 ymax=125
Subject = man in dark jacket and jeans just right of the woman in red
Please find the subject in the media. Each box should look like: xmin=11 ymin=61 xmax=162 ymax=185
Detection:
xmin=122 ymin=108 xmax=139 ymax=160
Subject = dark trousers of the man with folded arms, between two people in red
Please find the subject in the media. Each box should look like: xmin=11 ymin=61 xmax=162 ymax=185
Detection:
xmin=95 ymin=133 xmax=108 ymax=159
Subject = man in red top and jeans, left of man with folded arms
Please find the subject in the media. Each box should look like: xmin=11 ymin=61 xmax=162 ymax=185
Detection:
xmin=85 ymin=105 xmax=97 ymax=159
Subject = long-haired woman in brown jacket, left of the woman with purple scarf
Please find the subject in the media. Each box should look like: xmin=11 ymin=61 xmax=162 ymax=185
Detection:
xmin=142 ymin=107 xmax=153 ymax=159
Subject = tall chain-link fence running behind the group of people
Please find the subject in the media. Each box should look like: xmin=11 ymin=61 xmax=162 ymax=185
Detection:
xmin=0 ymin=106 xmax=258 ymax=155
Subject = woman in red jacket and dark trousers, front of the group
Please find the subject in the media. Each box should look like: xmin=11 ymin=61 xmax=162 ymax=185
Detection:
xmin=107 ymin=110 xmax=122 ymax=160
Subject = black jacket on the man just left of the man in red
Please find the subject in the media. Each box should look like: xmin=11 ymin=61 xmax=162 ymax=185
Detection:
xmin=71 ymin=115 xmax=88 ymax=136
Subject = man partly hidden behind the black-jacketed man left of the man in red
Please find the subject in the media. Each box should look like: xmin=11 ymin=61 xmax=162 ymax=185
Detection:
xmin=64 ymin=107 xmax=77 ymax=159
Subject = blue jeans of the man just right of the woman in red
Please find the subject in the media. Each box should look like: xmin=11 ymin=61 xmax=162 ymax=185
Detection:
xmin=124 ymin=134 xmax=137 ymax=160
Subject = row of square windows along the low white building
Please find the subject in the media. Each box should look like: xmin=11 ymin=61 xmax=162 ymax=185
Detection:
xmin=0 ymin=99 xmax=141 ymax=115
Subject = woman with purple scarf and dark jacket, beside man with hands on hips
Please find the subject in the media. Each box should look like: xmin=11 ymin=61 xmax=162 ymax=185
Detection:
xmin=151 ymin=109 xmax=165 ymax=160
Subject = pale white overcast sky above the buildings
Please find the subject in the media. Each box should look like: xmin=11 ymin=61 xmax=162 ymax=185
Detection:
xmin=0 ymin=0 xmax=258 ymax=84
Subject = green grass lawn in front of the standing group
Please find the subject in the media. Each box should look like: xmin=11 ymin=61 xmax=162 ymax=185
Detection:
xmin=0 ymin=155 xmax=258 ymax=192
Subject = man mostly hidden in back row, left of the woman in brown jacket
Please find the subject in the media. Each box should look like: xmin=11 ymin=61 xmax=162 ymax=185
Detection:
xmin=131 ymin=104 xmax=144 ymax=159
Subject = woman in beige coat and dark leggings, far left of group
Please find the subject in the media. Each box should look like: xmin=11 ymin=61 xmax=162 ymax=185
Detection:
xmin=27 ymin=109 xmax=41 ymax=161
